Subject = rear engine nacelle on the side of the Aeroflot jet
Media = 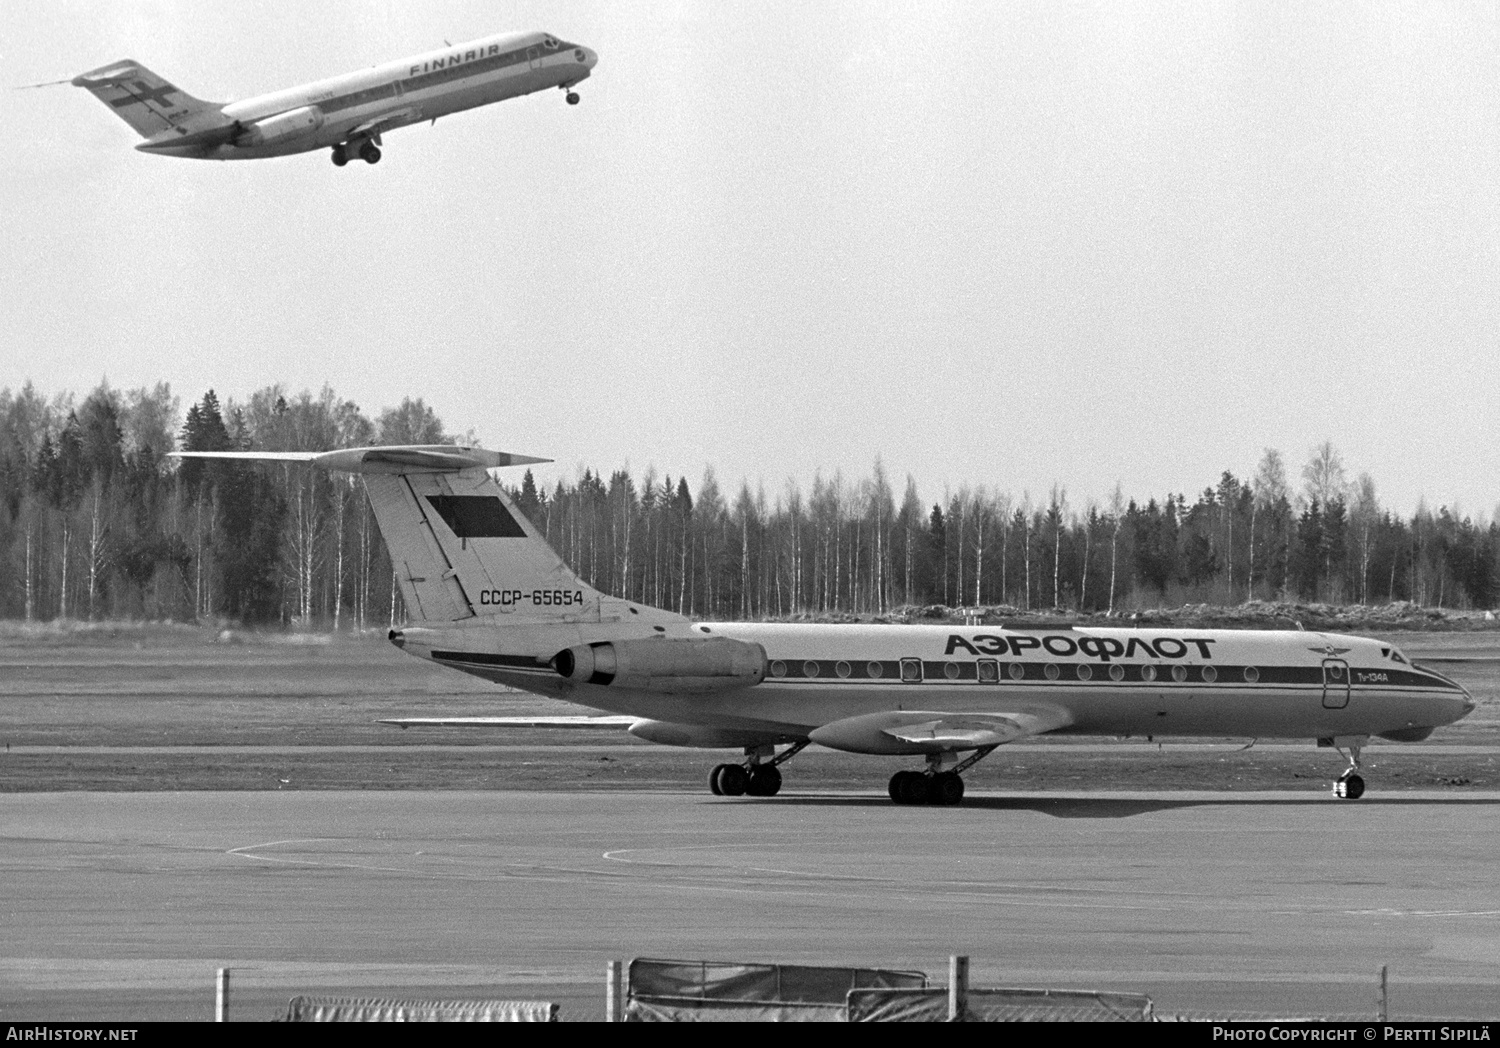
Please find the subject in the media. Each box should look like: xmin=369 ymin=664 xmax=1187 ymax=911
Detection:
xmin=552 ymin=637 xmax=765 ymax=693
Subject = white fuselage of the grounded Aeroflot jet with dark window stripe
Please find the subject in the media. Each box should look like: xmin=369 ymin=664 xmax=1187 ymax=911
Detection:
xmin=399 ymin=619 xmax=1473 ymax=753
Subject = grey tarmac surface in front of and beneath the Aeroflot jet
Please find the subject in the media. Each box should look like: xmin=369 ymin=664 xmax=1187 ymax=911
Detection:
xmin=0 ymin=784 xmax=1500 ymax=1021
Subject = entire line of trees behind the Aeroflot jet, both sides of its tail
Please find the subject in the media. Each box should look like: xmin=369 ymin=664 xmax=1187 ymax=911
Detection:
xmin=0 ymin=384 xmax=1500 ymax=628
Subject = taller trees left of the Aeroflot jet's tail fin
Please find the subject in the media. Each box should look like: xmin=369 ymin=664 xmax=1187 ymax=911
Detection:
xmin=0 ymin=384 xmax=449 ymax=628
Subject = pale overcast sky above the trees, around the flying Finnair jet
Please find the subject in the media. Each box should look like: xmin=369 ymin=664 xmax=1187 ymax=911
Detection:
xmin=0 ymin=0 xmax=1500 ymax=514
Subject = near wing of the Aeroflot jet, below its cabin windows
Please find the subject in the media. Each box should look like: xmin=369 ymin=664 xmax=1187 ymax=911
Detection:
xmin=809 ymin=703 xmax=1073 ymax=754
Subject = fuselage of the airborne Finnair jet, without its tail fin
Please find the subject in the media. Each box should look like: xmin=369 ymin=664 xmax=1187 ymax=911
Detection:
xmin=137 ymin=31 xmax=599 ymax=160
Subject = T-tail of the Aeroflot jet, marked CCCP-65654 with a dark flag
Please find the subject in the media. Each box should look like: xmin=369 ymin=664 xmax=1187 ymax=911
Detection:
xmin=176 ymin=444 xmax=681 ymax=625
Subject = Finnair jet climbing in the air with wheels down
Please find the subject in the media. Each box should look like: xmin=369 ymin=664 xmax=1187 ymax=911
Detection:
xmin=72 ymin=33 xmax=599 ymax=168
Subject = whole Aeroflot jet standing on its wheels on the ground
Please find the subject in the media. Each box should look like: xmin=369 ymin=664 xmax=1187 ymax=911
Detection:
xmin=180 ymin=445 xmax=1475 ymax=804
